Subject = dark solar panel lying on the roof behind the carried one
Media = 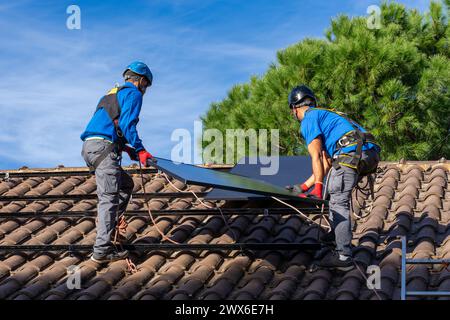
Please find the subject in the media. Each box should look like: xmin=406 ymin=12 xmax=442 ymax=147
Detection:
xmin=205 ymin=156 xmax=312 ymax=200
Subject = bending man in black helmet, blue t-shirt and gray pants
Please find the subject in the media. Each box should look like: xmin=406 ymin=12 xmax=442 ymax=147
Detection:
xmin=289 ymin=85 xmax=381 ymax=270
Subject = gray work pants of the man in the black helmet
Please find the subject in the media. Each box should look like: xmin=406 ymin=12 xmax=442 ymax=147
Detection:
xmin=327 ymin=149 xmax=380 ymax=256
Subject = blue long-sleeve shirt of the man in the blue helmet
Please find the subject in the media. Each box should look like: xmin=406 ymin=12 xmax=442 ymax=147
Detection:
xmin=80 ymin=82 xmax=144 ymax=151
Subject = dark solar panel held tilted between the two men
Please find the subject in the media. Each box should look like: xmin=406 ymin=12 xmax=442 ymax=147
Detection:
xmin=155 ymin=157 xmax=321 ymax=203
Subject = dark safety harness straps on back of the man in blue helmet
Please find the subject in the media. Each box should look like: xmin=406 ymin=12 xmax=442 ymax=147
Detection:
xmin=89 ymin=86 xmax=127 ymax=173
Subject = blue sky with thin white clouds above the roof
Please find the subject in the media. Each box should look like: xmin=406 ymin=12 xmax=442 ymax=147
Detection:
xmin=0 ymin=0 xmax=428 ymax=169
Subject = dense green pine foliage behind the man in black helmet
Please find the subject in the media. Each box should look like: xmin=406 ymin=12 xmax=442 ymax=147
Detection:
xmin=202 ymin=0 xmax=450 ymax=160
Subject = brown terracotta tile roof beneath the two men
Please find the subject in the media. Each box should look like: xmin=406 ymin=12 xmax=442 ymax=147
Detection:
xmin=0 ymin=162 xmax=450 ymax=300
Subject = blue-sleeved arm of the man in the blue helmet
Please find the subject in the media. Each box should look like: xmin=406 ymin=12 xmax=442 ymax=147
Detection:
xmin=119 ymin=90 xmax=145 ymax=152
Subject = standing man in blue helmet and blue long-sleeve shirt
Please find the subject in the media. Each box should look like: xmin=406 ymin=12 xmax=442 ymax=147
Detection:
xmin=81 ymin=61 xmax=153 ymax=263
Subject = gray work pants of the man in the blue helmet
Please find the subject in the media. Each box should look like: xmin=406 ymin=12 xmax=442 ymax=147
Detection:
xmin=81 ymin=139 xmax=134 ymax=254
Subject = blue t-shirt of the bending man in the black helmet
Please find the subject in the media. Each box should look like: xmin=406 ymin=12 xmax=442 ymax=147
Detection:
xmin=300 ymin=107 xmax=379 ymax=157
